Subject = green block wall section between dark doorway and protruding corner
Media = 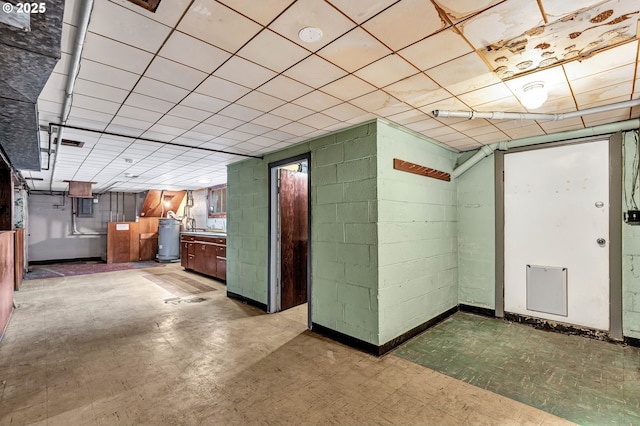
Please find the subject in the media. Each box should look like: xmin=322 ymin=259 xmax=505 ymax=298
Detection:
xmin=311 ymin=123 xmax=378 ymax=345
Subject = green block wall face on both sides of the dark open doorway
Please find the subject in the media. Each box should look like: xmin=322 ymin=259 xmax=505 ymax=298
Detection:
xmin=227 ymin=122 xmax=378 ymax=344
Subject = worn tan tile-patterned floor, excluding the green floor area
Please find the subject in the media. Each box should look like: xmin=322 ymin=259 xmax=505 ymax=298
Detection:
xmin=0 ymin=265 xmax=571 ymax=426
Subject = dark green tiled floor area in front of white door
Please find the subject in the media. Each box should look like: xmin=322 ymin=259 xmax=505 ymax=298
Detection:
xmin=393 ymin=312 xmax=640 ymax=425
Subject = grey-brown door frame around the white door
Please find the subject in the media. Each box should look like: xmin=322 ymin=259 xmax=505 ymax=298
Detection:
xmin=494 ymin=132 xmax=623 ymax=339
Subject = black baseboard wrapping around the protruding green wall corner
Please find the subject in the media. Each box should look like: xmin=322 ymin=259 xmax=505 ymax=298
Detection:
xmin=311 ymin=306 xmax=458 ymax=356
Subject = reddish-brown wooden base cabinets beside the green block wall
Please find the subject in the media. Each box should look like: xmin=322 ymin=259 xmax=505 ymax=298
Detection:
xmin=180 ymin=234 xmax=227 ymax=281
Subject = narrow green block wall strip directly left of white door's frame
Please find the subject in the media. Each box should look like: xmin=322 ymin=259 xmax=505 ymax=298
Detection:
xmin=458 ymin=155 xmax=496 ymax=309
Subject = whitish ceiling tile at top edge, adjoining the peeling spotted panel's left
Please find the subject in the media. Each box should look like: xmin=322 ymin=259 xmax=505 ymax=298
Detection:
xmin=457 ymin=0 xmax=545 ymax=49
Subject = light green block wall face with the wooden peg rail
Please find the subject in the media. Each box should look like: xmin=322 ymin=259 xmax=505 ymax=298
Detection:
xmin=377 ymin=122 xmax=458 ymax=344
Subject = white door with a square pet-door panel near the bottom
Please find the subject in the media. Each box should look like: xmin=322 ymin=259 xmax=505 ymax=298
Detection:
xmin=504 ymin=140 xmax=609 ymax=330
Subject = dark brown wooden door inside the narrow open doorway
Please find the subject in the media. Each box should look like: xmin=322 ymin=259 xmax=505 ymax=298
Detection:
xmin=280 ymin=169 xmax=309 ymax=310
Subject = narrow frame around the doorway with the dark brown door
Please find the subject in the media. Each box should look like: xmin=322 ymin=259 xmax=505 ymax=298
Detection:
xmin=267 ymin=152 xmax=312 ymax=329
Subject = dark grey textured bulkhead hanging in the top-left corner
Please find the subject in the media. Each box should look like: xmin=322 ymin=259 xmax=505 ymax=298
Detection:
xmin=0 ymin=0 xmax=64 ymax=170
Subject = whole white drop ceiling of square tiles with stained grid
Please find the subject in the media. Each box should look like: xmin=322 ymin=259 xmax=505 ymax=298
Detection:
xmin=23 ymin=0 xmax=640 ymax=191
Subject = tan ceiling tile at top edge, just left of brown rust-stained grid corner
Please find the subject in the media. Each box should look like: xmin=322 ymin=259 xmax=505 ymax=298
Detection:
xmin=362 ymin=0 xmax=448 ymax=51
